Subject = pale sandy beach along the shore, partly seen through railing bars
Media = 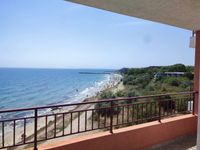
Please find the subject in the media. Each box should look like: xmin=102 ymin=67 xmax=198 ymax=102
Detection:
xmin=0 ymin=74 xmax=123 ymax=149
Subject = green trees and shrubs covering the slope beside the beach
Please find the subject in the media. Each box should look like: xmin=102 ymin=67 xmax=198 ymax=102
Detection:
xmin=95 ymin=64 xmax=194 ymax=118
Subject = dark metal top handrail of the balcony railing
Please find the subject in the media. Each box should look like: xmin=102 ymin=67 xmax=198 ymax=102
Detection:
xmin=0 ymin=91 xmax=195 ymax=113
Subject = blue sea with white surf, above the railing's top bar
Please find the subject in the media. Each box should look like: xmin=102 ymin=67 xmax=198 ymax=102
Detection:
xmin=0 ymin=68 xmax=113 ymax=110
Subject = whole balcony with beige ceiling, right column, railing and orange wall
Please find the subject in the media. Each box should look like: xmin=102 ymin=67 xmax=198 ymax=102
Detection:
xmin=0 ymin=0 xmax=200 ymax=150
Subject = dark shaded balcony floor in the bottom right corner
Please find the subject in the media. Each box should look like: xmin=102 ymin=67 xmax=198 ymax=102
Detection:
xmin=145 ymin=135 xmax=196 ymax=150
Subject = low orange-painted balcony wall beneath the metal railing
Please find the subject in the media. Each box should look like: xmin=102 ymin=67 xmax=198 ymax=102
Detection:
xmin=39 ymin=115 xmax=197 ymax=150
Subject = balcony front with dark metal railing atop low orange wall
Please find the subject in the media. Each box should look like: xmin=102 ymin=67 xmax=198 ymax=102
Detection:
xmin=0 ymin=92 xmax=197 ymax=149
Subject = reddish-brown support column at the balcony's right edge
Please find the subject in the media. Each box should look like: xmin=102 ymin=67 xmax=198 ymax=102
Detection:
xmin=194 ymin=31 xmax=200 ymax=150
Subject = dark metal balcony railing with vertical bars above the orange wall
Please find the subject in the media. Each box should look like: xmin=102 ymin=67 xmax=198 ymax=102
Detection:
xmin=0 ymin=92 xmax=196 ymax=150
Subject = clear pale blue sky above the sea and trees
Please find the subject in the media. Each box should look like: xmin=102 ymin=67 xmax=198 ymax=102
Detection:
xmin=0 ymin=0 xmax=194 ymax=69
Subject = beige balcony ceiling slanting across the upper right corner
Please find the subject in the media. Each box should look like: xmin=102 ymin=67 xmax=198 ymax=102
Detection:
xmin=67 ymin=0 xmax=200 ymax=31
